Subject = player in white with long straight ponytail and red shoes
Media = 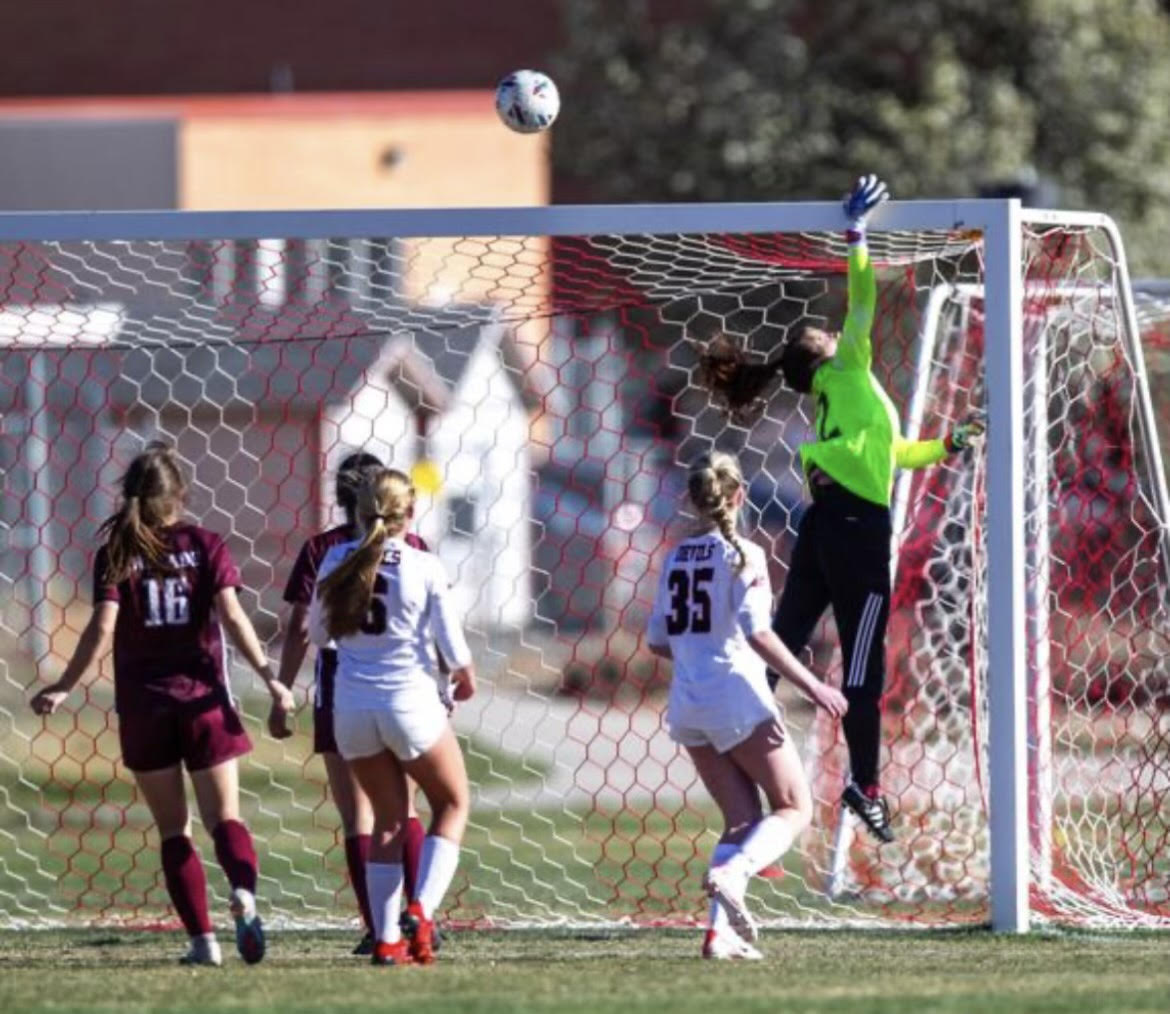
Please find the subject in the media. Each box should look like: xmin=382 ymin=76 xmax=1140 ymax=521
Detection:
xmin=309 ymin=468 xmax=475 ymax=965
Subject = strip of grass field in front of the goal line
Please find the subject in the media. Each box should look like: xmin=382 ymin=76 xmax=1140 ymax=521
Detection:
xmin=0 ymin=931 xmax=1170 ymax=1014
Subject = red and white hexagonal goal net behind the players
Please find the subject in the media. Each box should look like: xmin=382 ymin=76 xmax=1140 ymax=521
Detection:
xmin=0 ymin=205 xmax=1170 ymax=926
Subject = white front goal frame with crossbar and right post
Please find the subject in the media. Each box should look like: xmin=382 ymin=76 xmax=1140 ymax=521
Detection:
xmin=0 ymin=191 xmax=1168 ymax=932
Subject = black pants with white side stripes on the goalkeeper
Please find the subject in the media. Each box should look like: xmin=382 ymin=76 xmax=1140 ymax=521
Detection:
xmin=772 ymin=484 xmax=892 ymax=789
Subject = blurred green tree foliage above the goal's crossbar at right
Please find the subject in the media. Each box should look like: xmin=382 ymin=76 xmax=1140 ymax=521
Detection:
xmin=553 ymin=0 xmax=1170 ymax=274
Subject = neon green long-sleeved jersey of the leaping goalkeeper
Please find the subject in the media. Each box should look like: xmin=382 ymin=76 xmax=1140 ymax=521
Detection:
xmin=800 ymin=240 xmax=947 ymax=506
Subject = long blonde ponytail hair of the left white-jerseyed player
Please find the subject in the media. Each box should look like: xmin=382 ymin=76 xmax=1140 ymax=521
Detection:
xmin=321 ymin=468 xmax=414 ymax=639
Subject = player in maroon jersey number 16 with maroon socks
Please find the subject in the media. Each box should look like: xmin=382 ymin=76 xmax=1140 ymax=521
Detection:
xmin=32 ymin=443 xmax=294 ymax=965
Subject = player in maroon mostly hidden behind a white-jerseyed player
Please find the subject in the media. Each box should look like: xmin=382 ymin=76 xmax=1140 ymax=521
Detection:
xmin=268 ymin=451 xmax=427 ymax=954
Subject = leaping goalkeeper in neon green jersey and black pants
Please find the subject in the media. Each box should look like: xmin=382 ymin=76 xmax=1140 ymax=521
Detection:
xmin=700 ymin=175 xmax=983 ymax=842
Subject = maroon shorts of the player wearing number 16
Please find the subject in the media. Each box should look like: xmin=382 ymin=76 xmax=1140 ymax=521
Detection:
xmin=118 ymin=702 xmax=252 ymax=771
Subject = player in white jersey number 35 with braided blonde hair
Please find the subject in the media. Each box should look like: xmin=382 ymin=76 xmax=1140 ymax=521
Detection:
xmin=647 ymin=451 xmax=848 ymax=959
